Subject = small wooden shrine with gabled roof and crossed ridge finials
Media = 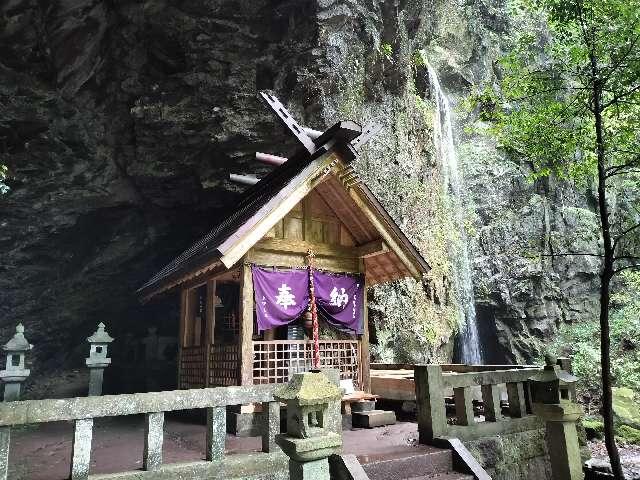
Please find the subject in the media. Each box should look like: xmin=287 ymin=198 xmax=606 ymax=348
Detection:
xmin=138 ymin=93 xmax=429 ymax=391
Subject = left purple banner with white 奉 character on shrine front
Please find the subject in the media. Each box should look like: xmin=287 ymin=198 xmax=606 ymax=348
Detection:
xmin=251 ymin=265 xmax=309 ymax=332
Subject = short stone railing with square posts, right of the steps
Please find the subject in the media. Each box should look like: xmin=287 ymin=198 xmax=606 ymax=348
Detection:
xmin=414 ymin=365 xmax=543 ymax=443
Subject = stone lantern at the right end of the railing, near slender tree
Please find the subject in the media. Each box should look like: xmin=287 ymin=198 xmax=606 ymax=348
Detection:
xmin=529 ymin=355 xmax=584 ymax=480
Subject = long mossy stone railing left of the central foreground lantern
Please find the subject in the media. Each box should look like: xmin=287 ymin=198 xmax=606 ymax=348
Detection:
xmin=0 ymin=385 xmax=287 ymax=480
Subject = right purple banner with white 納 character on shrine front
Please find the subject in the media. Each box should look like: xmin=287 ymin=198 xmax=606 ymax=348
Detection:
xmin=313 ymin=270 xmax=364 ymax=335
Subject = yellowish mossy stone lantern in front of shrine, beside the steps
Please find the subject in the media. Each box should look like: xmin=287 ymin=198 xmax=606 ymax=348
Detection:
xmin=274 ymin=371 xmax=342 ymax=480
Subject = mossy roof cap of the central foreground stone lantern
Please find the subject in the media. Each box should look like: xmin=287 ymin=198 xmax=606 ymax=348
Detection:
xmin=274 ymin=372 xmax=342 ymax=406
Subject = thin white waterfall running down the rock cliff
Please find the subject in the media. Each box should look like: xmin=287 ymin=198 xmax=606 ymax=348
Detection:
xmin=427 ymin=62 xmax=483 ymax=364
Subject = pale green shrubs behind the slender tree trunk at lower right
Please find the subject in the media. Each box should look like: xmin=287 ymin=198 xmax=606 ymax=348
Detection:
xmin=551 ymin=271 xmax=640 ymax=409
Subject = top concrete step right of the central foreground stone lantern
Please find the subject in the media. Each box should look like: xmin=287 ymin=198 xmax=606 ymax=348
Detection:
xmin=361 ymin=448 xmax=456 ymax=480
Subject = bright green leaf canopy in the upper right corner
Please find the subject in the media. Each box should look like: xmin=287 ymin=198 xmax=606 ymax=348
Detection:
xmin=467 ymin=0 xmax=640 ymax=190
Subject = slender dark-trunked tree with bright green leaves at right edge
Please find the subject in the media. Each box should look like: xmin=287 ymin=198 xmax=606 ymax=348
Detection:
xmin=475 ymin=0 xmax=640 ymax=479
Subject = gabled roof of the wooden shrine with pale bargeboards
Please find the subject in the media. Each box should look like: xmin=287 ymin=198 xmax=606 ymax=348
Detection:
xmin=138 ymin=117 xmax=429 ymax=298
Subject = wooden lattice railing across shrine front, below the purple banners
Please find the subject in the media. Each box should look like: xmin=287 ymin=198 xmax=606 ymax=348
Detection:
xmin=253 ymin=340 xmax=362 ymax=388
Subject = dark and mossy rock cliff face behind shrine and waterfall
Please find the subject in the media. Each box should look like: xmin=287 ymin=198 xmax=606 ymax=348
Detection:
xmin=0 ymin=0 xmax=597 ymax=390
